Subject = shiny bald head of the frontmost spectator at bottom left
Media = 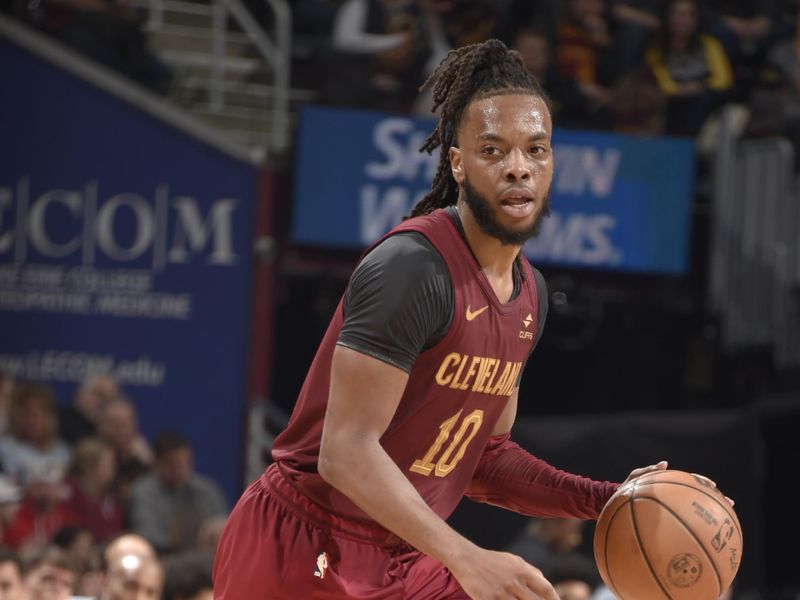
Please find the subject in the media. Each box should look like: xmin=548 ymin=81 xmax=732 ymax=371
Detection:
xmin=100 ymin=554 xmax=164 ymax=600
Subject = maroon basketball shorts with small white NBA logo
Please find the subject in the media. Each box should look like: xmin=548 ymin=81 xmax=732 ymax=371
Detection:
xmin=214 ymin=464 xmax=469 ymax=600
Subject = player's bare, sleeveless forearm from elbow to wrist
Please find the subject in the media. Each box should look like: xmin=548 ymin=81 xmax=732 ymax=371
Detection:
xmin=318 ymin=439 xmax=474 ymax=566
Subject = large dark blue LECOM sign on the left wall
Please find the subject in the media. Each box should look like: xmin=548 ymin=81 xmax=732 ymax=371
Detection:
xmin=0 ymin=39 xmax=257 ymax=501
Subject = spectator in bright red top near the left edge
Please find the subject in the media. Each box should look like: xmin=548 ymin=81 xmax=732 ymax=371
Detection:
xmin=3 ymin=465 xmax=75 ymax=551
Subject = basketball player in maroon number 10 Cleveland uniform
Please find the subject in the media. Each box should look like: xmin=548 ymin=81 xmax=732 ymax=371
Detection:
xmin=214 ymin=40 xmax=666 ymax=600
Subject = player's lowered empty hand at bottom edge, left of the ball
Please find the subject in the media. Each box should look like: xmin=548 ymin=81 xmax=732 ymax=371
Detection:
xmin=450 ymin=548 xmax=559 ymax=600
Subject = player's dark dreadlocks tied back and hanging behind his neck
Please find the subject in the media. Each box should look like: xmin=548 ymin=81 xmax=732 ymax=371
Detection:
xmin=411 ymin=40 xmax=549 ymax=217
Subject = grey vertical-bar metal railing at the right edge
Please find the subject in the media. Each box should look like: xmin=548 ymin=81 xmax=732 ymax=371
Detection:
xmin=709 ymin=107 xmax=800 ymax=368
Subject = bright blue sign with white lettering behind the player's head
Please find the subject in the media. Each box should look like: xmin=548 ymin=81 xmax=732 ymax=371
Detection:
xmin=292 ymin=107 xmax=694 ymax=274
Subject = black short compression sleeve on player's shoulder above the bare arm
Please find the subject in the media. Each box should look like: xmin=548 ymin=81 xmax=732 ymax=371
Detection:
xmin=338 ymin=232 xmax=453 ymax=372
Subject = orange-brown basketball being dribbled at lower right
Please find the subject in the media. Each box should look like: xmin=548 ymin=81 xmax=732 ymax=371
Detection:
xmin=594 ymin=470 xmax=742 ymax=600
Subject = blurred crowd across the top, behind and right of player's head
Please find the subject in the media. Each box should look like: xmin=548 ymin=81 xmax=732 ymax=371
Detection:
xmin=291 ymin=0 xmax=800 ymax=150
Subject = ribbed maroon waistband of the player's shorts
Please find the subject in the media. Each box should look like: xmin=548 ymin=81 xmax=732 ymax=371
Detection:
xmin=261 ymin=463 xmax=410 ymax=550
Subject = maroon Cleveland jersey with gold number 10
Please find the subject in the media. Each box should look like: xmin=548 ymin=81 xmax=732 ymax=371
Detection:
xmin=272 ymin=210 xmax=538 ymax=520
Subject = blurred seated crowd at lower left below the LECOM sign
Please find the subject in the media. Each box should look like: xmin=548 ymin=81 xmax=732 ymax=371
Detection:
xmin=0 ymin=373 xmax=229 ymax=600
